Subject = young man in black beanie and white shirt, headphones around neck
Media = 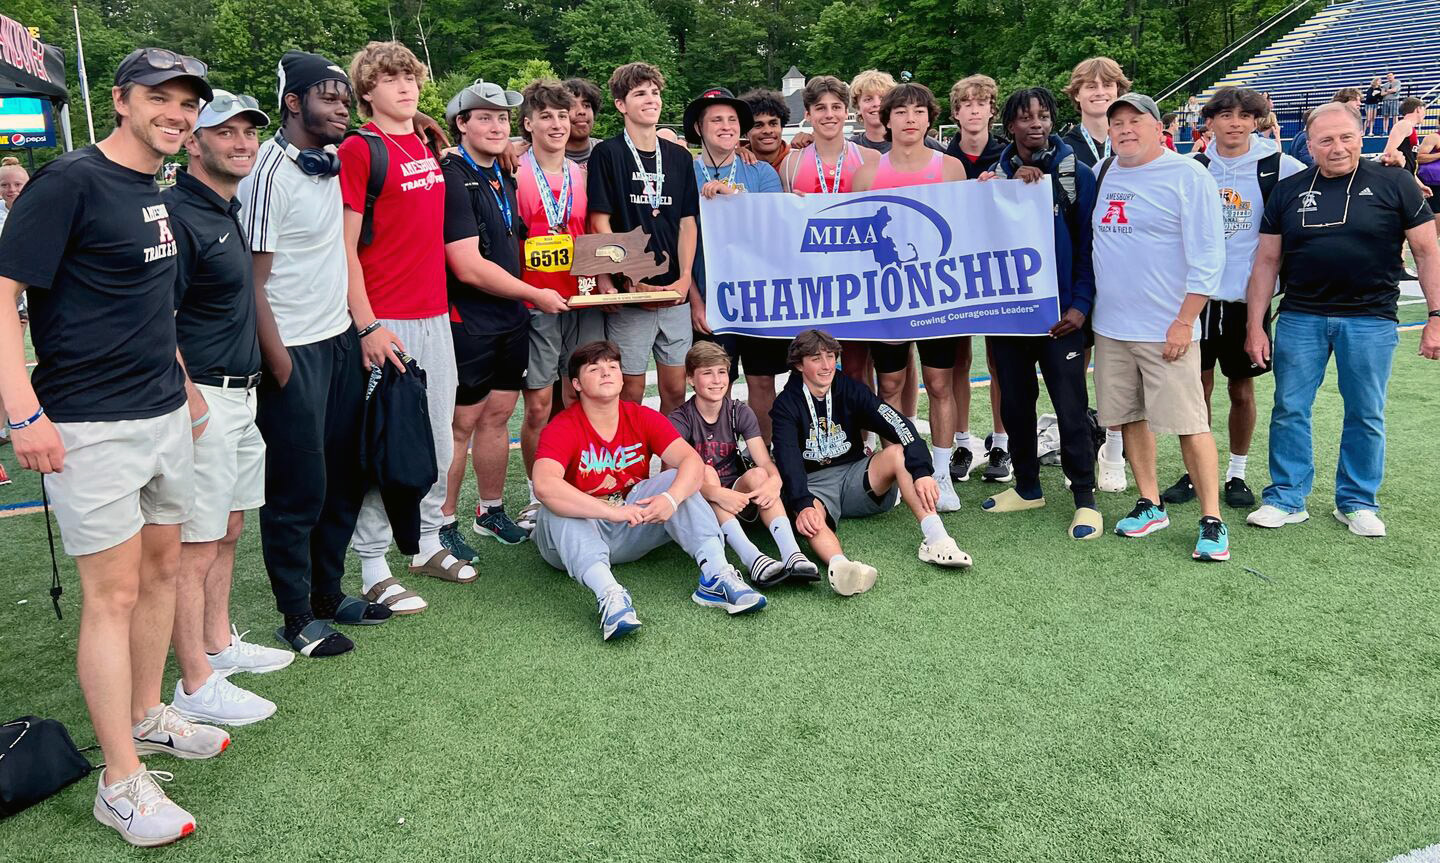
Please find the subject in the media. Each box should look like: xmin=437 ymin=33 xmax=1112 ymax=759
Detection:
xmin=239 ymin=50 xmax=392 ymax=657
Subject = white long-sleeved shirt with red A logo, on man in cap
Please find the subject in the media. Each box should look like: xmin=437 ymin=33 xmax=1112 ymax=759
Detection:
xmin=1090 ymin=150 xmax=1225 ymax=341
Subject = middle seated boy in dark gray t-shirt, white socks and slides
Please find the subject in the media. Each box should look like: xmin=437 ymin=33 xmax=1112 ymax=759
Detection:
xmin=670 ymin=341 xmax=819 ymax=588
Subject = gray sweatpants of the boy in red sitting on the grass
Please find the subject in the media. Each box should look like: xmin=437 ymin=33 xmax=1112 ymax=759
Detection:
xmin=530 ymin=470 xmax=724 ymax=581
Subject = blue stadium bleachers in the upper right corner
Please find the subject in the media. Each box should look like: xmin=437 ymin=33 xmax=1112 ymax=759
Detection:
xmin=1198 ymin=0 xmax=1440 ymax=137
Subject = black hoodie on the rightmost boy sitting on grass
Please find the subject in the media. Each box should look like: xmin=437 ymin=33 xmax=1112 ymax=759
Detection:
xmin=770 ymin=370 xmax=935 ymax=513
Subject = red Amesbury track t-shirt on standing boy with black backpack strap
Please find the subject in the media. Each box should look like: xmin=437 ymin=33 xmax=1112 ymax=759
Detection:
xmin=340 ymin=122 xmax=449 ymax=320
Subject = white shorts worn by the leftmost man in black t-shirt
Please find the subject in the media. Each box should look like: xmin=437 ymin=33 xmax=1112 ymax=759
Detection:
xmin=45 ymin=405 xmax=194 ymax=558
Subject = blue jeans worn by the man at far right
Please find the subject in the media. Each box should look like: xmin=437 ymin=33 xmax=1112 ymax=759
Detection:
xmin=1263 ymin=311 xmax=1400 ymax=513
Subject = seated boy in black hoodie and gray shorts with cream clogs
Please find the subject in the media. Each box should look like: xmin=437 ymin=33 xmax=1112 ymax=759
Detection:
xmin=770 ymin=330 xmax=971 ymax=596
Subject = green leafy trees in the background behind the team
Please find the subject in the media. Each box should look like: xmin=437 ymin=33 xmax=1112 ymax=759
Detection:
xmin=6 ymin=0 xmax=1289 ymax=156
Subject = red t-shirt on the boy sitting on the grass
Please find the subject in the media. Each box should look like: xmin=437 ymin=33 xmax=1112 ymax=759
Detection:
xmin=536 ymin=401 xmax=680 ymax=497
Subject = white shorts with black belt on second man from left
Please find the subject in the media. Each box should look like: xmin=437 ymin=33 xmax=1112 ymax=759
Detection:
xmin=180 ymin=385 xmax=265 ymax=542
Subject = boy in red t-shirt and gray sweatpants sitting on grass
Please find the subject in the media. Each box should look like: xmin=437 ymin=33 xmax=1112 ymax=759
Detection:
xmin=531 ymin=341 xmax=765 ymax=641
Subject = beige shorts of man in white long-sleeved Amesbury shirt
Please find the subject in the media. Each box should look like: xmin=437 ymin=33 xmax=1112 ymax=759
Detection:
xmin=1094 ymin=333 xmax=1210 ymax=435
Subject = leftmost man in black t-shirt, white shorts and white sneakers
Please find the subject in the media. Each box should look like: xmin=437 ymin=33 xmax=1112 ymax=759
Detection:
xmin=0 ymin=48 xmax=230 ymax=846
